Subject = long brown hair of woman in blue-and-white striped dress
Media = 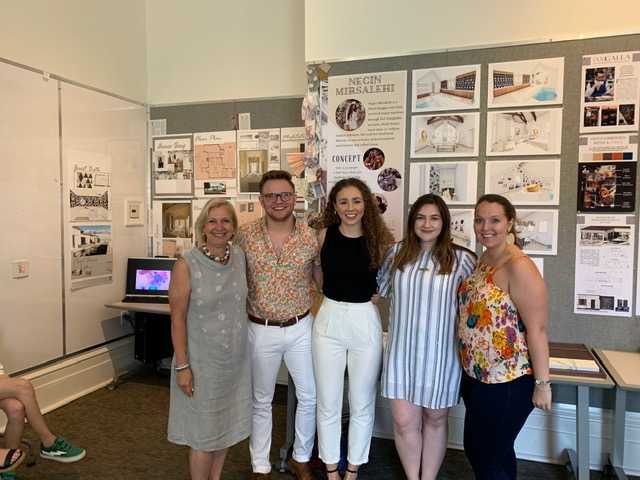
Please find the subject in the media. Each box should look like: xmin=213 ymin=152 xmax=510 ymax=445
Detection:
xmin=391 ymin=193 xmax=458 ymax=275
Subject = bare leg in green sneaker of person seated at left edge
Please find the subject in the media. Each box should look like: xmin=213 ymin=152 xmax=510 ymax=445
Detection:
xmin=0 ymin=375 xmax=86 ymax=462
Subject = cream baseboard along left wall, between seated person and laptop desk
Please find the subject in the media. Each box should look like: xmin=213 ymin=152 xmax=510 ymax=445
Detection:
xmin=0 ymin=337 xmax=139 ymax=430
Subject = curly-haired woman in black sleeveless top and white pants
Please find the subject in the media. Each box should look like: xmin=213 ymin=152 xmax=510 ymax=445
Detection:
xmin=312 ymin=178 xmax=393 ymax=480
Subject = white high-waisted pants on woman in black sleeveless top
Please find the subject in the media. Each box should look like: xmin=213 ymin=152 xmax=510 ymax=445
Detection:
xmin=313 ymin=298 xmax=382 ymax=465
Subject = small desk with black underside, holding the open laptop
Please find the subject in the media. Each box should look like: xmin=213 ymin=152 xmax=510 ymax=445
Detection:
xmin=105 ymin=302 xmax=173 ymax=383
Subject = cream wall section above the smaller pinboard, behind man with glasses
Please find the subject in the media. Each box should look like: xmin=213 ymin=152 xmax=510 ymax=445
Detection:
xmin=147 ymin=0 xmax=306 ymax=105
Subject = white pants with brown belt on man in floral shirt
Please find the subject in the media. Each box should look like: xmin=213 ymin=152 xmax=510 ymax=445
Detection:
xmin=249 ymin=314 xmax=316 ymax=473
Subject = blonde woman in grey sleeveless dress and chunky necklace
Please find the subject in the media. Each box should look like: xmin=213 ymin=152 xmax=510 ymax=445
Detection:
xmin=168 ymin=199 xmax=251 ymax=480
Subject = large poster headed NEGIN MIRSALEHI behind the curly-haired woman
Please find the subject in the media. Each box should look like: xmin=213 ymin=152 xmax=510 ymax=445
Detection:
xmin=323 ymin=72 xmax=407 ymax=240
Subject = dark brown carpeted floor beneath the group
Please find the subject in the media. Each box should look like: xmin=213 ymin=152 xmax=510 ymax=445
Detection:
xmin=8 ymin=371 xmax=638 ymax=480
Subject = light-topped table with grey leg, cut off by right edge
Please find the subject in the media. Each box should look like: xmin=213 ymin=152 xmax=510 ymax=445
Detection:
xmin=595 ymin=350 xmax=640 ymax=480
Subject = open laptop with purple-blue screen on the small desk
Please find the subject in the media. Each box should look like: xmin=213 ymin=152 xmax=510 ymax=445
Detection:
xmin=122 ymin=257 xmax=176 ymax=303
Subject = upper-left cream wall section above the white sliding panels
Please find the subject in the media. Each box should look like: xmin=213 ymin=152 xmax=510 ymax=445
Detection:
xmin=0 ymin=0 xmax=147 ymax=101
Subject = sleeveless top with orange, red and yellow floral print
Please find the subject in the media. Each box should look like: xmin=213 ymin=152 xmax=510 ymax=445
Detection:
xmin=458 ymin=263 xmax=532 ymax=383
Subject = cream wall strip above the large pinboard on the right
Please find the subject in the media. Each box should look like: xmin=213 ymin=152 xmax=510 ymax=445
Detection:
xmin=305 ymin=0 xmax=640 ymax=62
